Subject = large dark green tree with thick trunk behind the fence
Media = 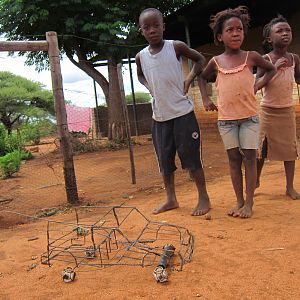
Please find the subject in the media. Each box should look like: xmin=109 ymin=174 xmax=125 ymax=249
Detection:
xmin=0 ymin=0 xmax=191 ymax=139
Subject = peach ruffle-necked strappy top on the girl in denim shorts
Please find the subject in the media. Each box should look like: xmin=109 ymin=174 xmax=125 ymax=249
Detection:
xmin=214 ymin=52 xmax=258 ymax=120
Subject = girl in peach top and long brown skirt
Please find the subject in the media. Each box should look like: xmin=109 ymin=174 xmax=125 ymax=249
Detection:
xmin=256 ymin=16 xmax=300 ymax=199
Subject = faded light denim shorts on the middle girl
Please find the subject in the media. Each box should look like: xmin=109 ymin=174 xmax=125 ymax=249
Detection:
xmin=218 ymin=115 xmax=260 ymax=150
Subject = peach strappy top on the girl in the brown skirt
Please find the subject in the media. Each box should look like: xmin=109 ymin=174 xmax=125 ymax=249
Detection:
xmin=261 ymin=54 xmax=295 ymax=108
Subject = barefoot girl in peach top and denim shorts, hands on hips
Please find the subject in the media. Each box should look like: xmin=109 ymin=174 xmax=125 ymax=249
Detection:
xmin=198 ymin=6 xmax=275 ymax=218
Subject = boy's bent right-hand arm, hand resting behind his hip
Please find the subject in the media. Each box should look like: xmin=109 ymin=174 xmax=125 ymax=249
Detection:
xmin=173 ymin=41 xmax=205 ymax=94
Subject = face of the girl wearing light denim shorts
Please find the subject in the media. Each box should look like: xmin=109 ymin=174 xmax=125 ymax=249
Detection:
xmin=218 ymin=17 xmax=245 ymax=50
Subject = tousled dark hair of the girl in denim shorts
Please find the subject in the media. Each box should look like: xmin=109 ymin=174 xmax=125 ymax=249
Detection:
xmin=209 ymin=6 xmax=251 ymax=45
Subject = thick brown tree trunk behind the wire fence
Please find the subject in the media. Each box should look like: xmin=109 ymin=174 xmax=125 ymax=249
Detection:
xmin=108 ymin=57 xmax=126 ymax=141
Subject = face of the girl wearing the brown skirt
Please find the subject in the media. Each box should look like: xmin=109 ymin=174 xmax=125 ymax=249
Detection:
xmin=270 ymin=22 xmax=292 ymax=47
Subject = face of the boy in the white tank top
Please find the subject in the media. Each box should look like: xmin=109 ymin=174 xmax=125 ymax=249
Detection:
xmin=139 ymin=11 xmax=165 ymax=45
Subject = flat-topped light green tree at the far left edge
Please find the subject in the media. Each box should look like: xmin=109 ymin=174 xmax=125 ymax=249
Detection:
xmin=0 ymin=72 xmax=54 ymax=134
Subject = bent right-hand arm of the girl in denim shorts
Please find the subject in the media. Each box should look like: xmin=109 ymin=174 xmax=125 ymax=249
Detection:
xmin=251 ymin=51 xmax=276 ymax=93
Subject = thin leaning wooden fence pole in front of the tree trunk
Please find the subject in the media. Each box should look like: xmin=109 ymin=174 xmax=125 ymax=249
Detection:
xmin=117 ymin=64 xmax=136 ymax=184
